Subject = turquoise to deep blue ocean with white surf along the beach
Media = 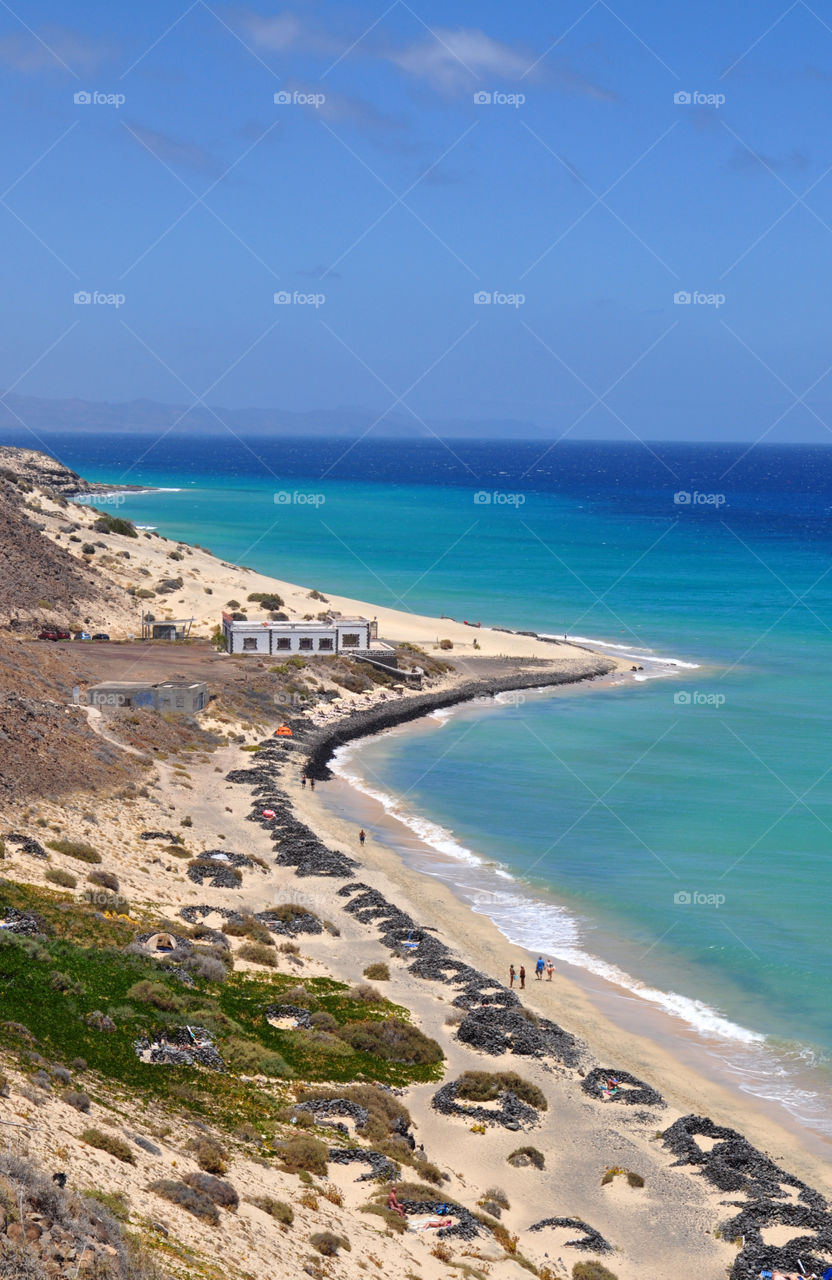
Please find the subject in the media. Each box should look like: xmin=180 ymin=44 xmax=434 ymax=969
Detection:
xmin=8 ymin=434 xmax=832 ymax=1135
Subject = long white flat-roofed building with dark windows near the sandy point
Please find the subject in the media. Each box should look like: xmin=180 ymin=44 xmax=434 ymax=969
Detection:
xmin=217 ymin=613 xmax=396 ymax=666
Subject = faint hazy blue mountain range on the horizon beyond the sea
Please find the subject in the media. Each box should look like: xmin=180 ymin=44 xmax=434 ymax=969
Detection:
xmin=0 ymin=394 xmax=540 ymax=440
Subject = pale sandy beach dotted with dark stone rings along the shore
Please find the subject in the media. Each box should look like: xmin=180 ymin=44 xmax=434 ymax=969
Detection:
xmin=0 ymin=460 xmax=832 ymax=1280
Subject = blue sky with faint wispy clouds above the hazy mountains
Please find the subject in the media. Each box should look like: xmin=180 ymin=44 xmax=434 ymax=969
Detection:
xmin=0 ymin=0 xmax=832 ymax=442
